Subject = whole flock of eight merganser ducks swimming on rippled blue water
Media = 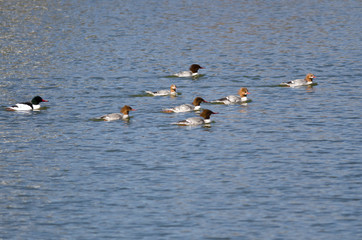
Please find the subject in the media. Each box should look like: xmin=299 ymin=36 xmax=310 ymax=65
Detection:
xmin=6 ymin=64 xmax=315 ymax=126
